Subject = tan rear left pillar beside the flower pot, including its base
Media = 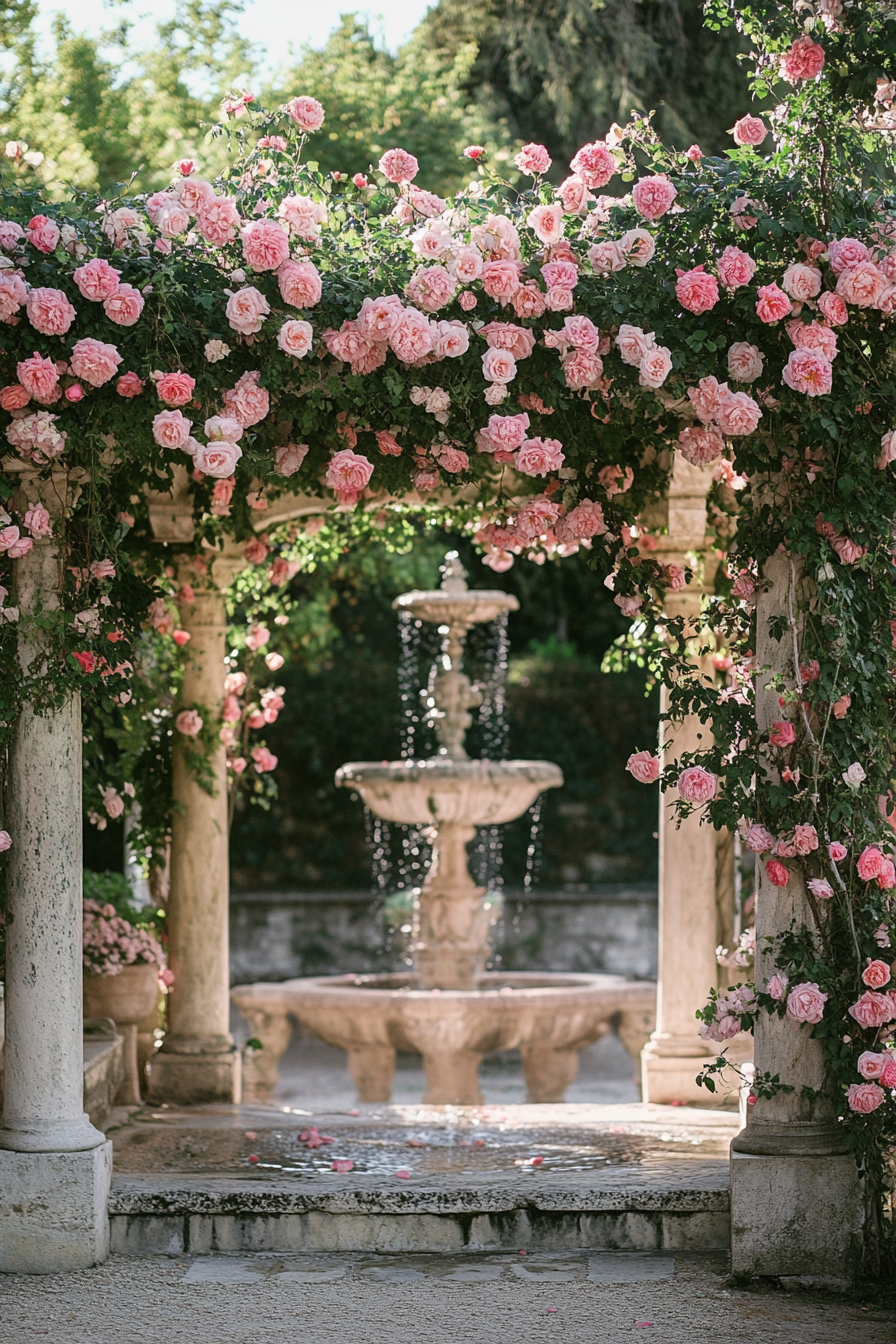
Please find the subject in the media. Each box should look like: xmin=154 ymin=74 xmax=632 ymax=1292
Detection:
xmin=149 ymin=547 xmax=246 ymax=1105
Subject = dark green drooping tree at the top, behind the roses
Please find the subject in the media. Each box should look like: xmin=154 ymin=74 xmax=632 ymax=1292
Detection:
xmin=418 ymin=0 xmax=750 ymax=165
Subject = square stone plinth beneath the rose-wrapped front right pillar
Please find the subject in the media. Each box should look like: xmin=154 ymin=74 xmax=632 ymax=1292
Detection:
xmin=731 ymin=1152 xmax=865 ymax=1289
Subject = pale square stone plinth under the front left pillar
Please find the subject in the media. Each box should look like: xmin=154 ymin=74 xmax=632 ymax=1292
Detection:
xmin=0 ymin=1141 xmax=111 ymax=1274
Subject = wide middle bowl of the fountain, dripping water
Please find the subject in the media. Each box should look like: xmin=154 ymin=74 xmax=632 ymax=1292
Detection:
xmin=336 ymin=757 xmax=563 ymax=827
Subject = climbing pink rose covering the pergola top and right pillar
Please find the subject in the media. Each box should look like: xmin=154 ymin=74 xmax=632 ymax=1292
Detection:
xmin=0 ymin=0 xmax=896 ymax=1247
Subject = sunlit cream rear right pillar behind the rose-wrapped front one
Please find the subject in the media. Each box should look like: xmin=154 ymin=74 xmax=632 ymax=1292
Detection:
xmin=641 ymin=454 xmax=748 ymax=1106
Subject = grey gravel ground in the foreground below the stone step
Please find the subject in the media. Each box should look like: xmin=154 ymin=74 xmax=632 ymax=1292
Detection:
xmin=0 ymin=1255 xmax=896 ymax=1344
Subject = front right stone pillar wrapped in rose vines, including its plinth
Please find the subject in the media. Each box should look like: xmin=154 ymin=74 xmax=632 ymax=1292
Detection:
xmin=731 ymin=554 xmax=864 ymax=1286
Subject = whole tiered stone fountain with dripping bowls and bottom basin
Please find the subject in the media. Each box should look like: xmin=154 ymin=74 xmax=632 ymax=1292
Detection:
xmin=232 ymin=552 xmax=656 ymax=1105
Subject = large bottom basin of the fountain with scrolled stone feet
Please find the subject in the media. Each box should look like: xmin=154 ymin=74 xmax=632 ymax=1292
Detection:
xmin=232 ymin=972 xmax=656 ymax=1106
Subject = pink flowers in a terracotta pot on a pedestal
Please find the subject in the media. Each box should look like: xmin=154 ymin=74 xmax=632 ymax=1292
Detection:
xmin=83 ymin=899 xmax=173 ymax=1105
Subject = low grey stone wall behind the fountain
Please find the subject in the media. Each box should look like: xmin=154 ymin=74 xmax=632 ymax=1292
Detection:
xmin=230 ymin=883 xmax=657 ymax=984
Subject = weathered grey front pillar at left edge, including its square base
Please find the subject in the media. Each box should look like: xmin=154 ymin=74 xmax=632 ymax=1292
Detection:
xmin=0 ymin=472 xmax=111 ymax=1274
